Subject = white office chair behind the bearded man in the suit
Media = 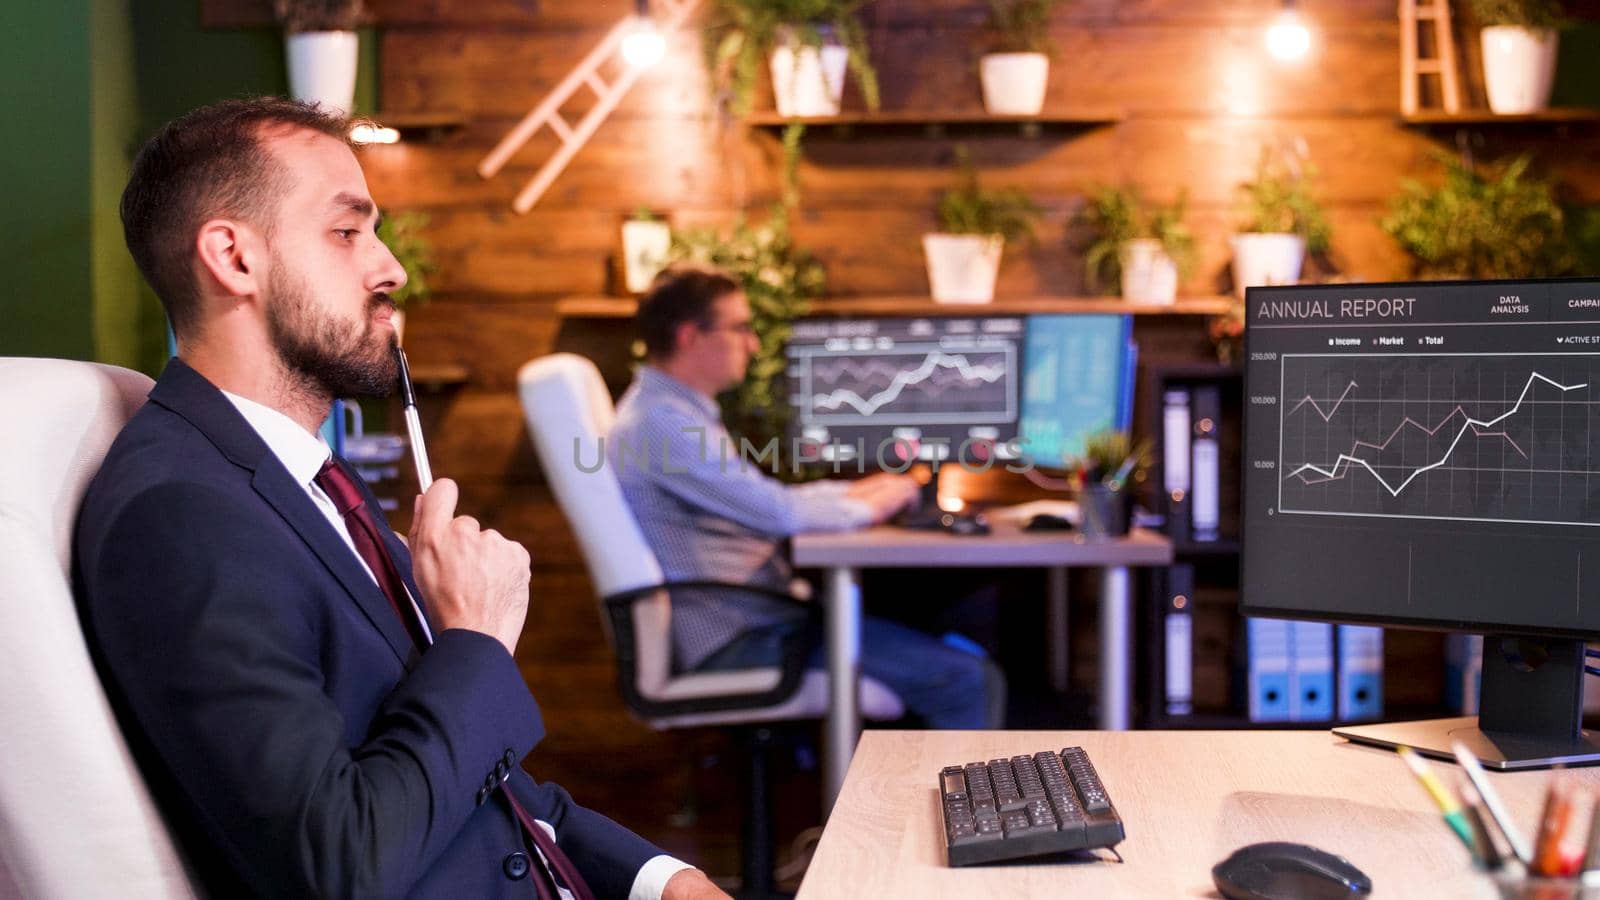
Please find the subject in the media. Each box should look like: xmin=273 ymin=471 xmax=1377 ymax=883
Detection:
xmin=0 ymin=357 xmax=195 ymax=898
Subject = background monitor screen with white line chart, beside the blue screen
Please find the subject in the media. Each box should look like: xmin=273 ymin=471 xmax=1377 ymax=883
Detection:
xmin=787 ymin=315 xmax=1022 ymax=469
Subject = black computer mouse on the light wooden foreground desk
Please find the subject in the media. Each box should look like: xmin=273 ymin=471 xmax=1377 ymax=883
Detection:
xmin=1211 ymin=841 xmax=1373 ymax=900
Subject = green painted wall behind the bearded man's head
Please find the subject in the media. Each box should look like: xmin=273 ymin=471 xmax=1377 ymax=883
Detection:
xmin=0 ymin=0 xmax=378 ymax=373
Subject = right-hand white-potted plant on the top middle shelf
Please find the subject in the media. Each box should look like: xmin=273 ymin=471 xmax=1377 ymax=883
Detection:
xmin=978 ymin=0 xmax=1058 ymax=115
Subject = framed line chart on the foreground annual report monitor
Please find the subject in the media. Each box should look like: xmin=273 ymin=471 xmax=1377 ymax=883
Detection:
xmin=1277 ymin=352 xmax=1600 ymax=524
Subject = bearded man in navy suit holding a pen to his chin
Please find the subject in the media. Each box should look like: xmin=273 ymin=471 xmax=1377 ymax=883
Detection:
xmin=75 ymin=99 xmax=726 ymax=900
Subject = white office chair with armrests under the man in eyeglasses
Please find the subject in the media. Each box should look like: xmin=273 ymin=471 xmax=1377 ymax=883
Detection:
xmin=517 ymin=354 xmax=904 ymax=894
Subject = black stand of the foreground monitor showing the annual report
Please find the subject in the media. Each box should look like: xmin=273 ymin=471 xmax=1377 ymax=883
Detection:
xmin=1333 ymin=634 xmax=1600 ymax=770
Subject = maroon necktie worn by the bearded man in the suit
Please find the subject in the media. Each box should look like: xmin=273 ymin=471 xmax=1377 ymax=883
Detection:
xmin=315 ymin=456 xmax=594 ymax=900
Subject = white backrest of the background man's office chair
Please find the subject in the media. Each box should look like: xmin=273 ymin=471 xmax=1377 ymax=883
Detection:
xmin=517 ymin=354 xmax=662 ymax=597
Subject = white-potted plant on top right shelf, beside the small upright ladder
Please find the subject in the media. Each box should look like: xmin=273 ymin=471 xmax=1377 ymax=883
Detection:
xmin=1472 ymin=0 xmax=1565 ymax=115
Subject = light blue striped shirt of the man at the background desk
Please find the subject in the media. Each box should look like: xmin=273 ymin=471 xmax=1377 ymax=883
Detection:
xmin=605 ymin=365 xmax=872 ymax=668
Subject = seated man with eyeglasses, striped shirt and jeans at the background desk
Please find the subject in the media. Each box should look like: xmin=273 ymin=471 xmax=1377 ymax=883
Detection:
xmin=605 ymin=266 xmax=1005 ymax=729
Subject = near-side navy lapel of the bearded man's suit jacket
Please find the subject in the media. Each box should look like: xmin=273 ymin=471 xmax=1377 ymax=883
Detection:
xmin=150 ymin=357 xmax=416 ymax=666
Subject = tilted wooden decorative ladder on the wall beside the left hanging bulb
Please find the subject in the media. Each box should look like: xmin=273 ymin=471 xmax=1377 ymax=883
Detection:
xmin=478 ymin=0 xmax=701 ymax=213
